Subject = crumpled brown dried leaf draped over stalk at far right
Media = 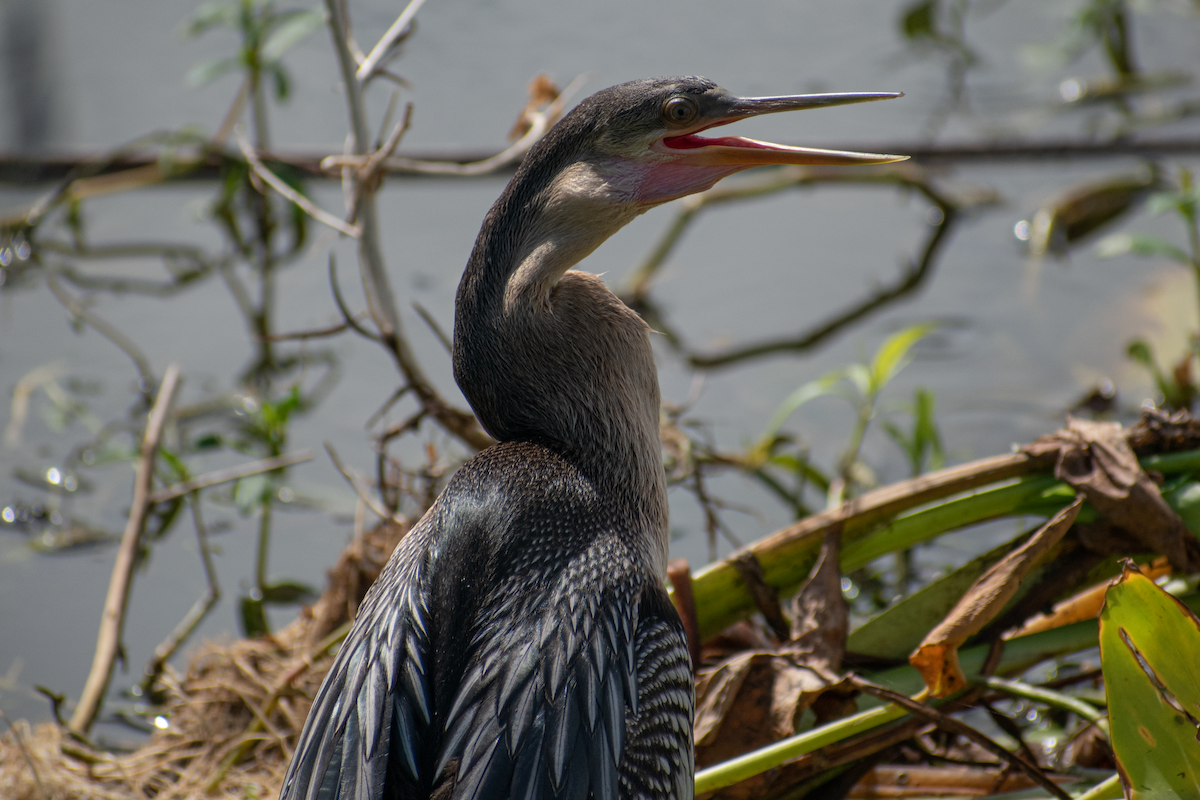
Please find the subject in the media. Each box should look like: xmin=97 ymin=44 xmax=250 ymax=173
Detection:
xmin=1025 ymin=419 xmax=1193 ymax=572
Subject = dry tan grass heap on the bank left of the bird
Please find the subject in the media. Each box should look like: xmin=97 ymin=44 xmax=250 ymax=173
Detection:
xmin=0 ymin=525 xmax=407 ymax=800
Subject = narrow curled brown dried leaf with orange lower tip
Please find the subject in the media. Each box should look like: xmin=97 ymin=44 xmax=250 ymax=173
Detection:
xmin=908 ymin=497 xmax=1084 ymax=697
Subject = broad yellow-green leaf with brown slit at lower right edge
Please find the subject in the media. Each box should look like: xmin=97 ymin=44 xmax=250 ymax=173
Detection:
xmin=1100 ymin=565 xmax=1200 ymax=800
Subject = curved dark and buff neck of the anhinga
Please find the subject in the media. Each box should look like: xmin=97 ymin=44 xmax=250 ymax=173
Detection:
xmin=454 ymin=153 xmax=667 ymax=573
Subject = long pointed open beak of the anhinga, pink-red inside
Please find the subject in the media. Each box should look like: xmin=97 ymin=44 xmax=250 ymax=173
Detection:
xmin=662 ymin=91 xmax=908 ymax=168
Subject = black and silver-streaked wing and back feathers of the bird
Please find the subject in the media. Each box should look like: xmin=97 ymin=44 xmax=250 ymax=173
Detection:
xmin=281 ymin=445 xmax=694 ymax=800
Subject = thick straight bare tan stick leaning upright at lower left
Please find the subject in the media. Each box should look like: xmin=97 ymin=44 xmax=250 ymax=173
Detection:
xmin=70 ymin=363 xmax=180 ymax=735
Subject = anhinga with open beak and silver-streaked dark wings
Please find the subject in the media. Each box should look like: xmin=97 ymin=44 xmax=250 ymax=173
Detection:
xmin=281 ymin=78 xmax=901 ymax=800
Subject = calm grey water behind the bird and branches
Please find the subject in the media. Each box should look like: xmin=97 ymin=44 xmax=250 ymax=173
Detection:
xmin=0 ymin=0 xmax=1200 ymax=735
